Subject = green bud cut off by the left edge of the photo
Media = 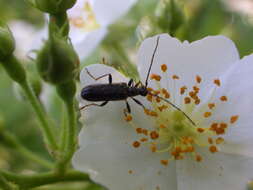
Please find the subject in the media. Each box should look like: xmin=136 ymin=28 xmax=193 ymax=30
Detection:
xmin=0 ymin=22 xmax=15 ymax=62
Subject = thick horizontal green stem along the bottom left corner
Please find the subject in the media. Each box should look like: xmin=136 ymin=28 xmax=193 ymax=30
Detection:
xmin=2 ymin=171 xmax=91 ymax=189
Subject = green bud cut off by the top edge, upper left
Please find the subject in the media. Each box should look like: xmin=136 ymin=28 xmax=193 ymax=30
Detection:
xmin=30 ymin=0 xmax=76 ymax=14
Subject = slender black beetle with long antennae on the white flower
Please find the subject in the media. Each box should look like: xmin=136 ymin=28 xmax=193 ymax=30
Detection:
xmin=80 ymin=36 xmax=195 ymax=125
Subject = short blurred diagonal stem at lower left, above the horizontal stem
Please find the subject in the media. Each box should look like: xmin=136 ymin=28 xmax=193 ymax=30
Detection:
xmin=0 ymin=131 xmax=53 ymax=169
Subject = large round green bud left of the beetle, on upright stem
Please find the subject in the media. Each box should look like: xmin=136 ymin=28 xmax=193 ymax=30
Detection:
xmin=37 ymin=36 xmax=79 ymax=84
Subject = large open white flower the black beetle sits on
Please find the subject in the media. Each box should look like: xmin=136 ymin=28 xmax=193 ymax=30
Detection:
xmin=72 ymin=34 xmax=253 ymax=190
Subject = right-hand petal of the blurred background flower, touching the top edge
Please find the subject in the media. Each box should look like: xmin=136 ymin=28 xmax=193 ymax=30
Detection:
xmin=92 ymin=0 xmax=136 ymax=26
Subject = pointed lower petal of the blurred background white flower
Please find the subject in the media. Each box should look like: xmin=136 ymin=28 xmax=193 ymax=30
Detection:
xmin=70 ymin=28 xmax=107 ymax=60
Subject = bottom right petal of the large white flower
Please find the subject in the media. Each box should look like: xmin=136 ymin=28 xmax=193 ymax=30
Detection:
xmin=176 ymin=151 xmax=253 ymax=190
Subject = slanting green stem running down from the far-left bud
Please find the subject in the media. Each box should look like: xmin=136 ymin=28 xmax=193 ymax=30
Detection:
xmin=20 ymin=81 xmax=57 ymax=150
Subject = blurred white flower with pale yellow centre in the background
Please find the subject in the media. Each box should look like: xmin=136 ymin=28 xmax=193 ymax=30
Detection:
xmin=68 ymin=0 xmax=136 ymax=59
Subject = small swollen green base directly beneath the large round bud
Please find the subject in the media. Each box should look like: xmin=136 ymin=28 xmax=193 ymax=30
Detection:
xmin=56 ymin=80 xmax=76 ymax=103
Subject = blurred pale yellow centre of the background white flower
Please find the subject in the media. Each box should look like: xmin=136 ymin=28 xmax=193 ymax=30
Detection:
xmin=69 ymin=2 xmax=100 ymax=32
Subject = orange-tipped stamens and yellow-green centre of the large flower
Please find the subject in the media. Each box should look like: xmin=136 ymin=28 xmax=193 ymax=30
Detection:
xmin=125 ymin=65 xmax=239 ymax=165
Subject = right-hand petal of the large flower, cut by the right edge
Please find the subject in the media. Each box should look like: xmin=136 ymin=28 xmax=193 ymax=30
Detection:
xmin=202 ymin=55 xmax=253 ymax=157
